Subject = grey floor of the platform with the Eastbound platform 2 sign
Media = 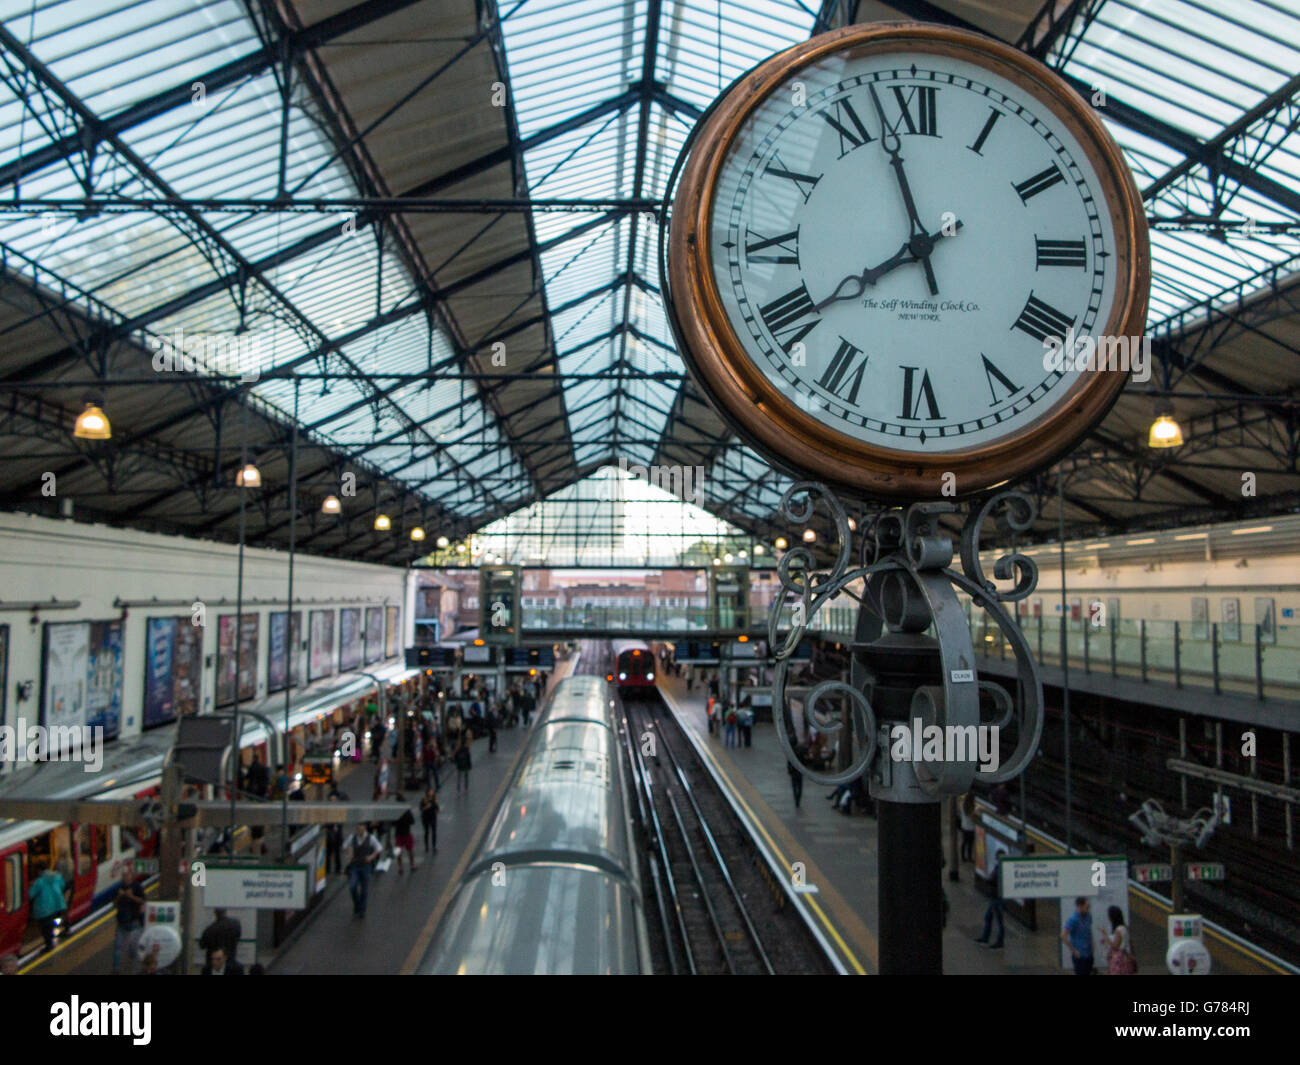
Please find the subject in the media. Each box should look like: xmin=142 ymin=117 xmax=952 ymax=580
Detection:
xmin=659 ymin=675 xmax=1277 ymax=975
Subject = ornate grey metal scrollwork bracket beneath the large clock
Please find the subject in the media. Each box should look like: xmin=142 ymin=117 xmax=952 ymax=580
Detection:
xmin=768 ymin=481 xmax=1043 ymax=801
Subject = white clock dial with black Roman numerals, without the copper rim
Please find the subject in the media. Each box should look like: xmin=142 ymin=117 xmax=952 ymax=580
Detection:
xmin=710 ymin=51 xmax=1121 ymax=454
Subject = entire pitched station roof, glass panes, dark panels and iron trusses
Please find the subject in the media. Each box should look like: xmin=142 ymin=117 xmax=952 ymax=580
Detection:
xmin=0 ymin=0 xmax=1300 ymax=562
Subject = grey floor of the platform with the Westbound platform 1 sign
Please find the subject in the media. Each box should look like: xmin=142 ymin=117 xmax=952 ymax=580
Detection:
xmin=22 ymin=655 xmax=579 ymax=975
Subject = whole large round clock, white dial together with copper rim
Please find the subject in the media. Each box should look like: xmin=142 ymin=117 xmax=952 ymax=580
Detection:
xmin=672 ymin=23 xmax=1145 ymax=495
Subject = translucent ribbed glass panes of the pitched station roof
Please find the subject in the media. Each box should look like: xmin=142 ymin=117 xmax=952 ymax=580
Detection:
xmin=0 ymin=0 xmax=1300 ymax=546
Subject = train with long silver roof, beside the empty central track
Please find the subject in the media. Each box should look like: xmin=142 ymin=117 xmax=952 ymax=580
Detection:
xmin=416 ymin=676 xmax=651 ymax=975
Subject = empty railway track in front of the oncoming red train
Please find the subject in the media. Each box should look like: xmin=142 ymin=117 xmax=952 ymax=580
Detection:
xmin=624 ymin=696 xmax=835 ymax=975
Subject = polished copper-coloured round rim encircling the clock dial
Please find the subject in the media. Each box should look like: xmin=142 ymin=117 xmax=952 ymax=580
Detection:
xmin=666 ymin=22 xmax=1151 ymax=499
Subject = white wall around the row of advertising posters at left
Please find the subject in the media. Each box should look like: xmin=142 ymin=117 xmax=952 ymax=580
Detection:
xmin=0 ymin=514 xmax=413 ymax=737
